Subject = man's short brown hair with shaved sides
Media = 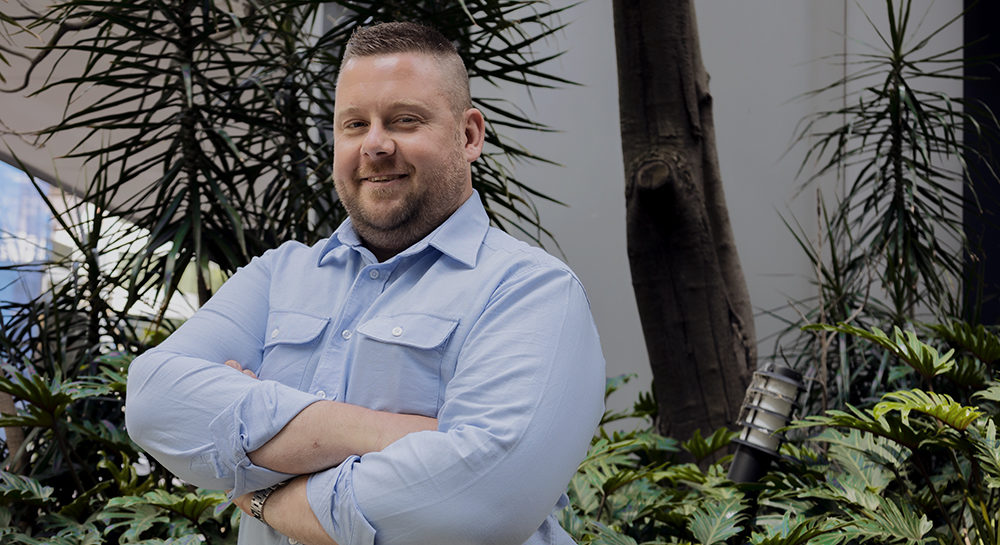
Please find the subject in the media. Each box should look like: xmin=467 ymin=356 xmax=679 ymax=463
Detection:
xmin=341 ymin=21 xmax=472 ymax=113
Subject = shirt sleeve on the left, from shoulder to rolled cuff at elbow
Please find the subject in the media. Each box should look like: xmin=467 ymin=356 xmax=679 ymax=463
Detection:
xmin=125 ymin=249 xmax=318 ymax=497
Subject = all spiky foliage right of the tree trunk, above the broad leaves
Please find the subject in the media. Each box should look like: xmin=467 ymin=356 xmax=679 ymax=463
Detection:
xmin=776 ymin=0 xmax=1000 ymax=410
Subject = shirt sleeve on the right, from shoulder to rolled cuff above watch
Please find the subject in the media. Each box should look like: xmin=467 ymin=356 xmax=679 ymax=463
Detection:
xmin=307 ymin=267 xmax=605 ymax=545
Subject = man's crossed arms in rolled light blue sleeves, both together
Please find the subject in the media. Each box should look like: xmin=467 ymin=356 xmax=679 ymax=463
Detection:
xmin=126 ymin=246 xmax=604 ymax=545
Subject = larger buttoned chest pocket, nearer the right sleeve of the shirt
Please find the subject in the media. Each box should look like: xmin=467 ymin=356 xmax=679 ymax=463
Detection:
xmin=346 ymin=313 xmax=458 ymax=416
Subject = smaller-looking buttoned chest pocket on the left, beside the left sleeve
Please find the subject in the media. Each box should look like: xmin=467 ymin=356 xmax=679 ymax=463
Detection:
xmin=257 ymin=310 xmax=330 ymax=389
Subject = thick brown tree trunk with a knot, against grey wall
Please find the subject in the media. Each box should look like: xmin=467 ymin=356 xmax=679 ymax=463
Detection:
xmin=614 ymin=0 xmax=757 ymax=440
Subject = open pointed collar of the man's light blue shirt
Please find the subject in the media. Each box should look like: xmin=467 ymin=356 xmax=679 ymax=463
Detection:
xmin=318 ymin=190 xmax=490 ymax=268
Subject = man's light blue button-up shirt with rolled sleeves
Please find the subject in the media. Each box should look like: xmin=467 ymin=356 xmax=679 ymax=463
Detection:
xmin=126 ymin=191 xmax=605 ymax=545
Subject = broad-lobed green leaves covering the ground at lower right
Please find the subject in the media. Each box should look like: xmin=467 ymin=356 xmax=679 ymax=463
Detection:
xmin=563 ymin=323 xmax=1000 ymax=545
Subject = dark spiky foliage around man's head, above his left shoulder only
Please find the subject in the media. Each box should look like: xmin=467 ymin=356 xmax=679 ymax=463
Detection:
xmin=4 ymin=0 xmax=568 ymax=310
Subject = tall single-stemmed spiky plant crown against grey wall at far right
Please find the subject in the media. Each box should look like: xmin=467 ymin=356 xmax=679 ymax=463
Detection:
xmin=796 ymin=0 xmax=998 ymax=324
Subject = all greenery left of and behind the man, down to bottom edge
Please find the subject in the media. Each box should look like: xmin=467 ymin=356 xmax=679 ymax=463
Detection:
xmin=0 ymin=0 xmax=580 ymax=544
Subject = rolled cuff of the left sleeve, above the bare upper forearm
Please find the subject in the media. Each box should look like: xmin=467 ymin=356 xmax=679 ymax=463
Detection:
xmin=208 ymin=380 xmax=320 ymax=498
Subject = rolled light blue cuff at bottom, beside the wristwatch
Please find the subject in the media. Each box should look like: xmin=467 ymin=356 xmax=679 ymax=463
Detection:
xmin=306 ymin=456 xmax=375 ymax=545
